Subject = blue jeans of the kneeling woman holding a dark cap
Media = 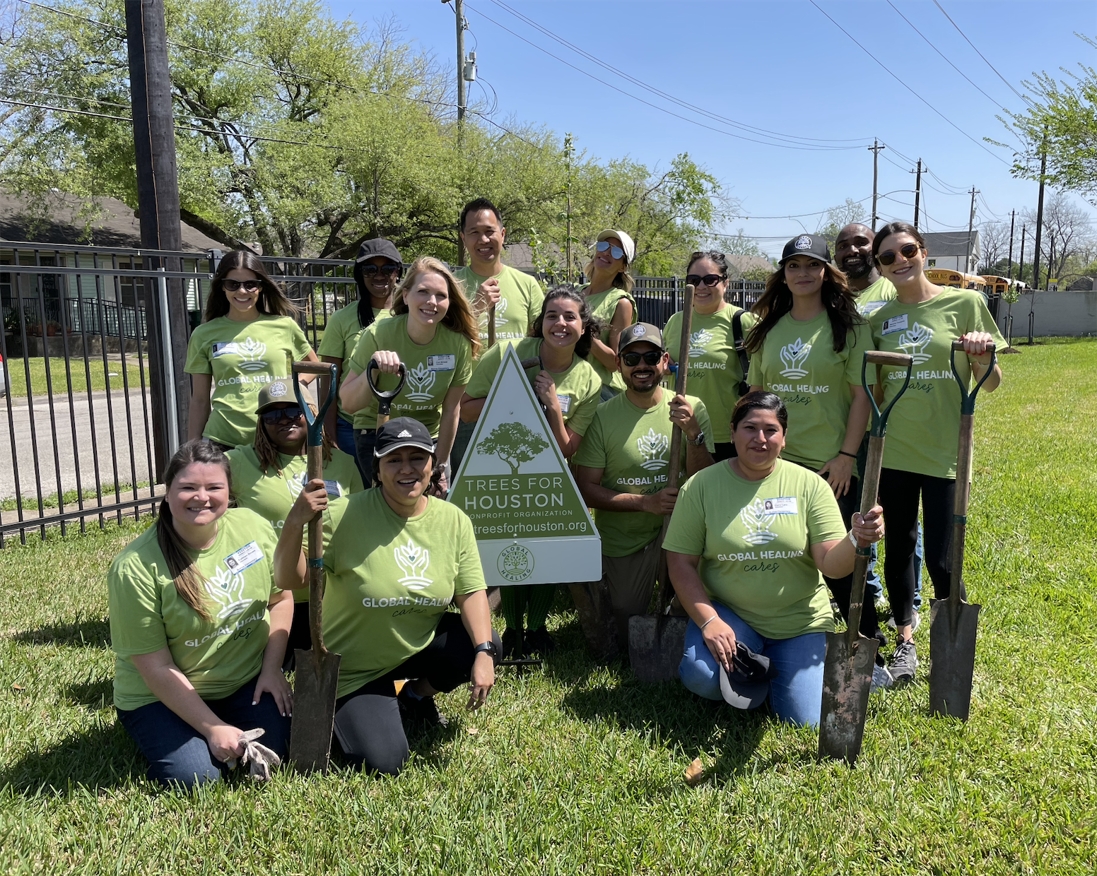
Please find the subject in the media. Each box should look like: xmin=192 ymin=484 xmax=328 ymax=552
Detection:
xmin=678 ymin=601 xmax=826 ymax=727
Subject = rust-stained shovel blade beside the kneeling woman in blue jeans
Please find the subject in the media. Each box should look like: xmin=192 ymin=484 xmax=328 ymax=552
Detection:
xmin=819 ymin=633 xmax=880 ymax=766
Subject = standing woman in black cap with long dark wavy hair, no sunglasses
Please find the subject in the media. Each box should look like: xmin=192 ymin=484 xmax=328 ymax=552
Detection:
xmin=746 ymin=235 xmax=885 ymax=664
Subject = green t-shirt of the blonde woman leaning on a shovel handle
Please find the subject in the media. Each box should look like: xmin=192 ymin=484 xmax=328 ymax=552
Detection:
xmin=347 ymin=314 xmax=473 ymax=437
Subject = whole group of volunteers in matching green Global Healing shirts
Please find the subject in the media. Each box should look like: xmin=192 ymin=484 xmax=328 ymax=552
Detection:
xmin=108 ymin=198 xmax=1004 ymax=787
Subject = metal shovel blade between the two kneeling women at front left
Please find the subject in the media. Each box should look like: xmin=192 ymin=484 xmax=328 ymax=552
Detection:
xmin=290 ymin=649 xmax=340 ymax=773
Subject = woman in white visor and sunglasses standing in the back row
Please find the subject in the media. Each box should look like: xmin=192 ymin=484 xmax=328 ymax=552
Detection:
xmin=580 ymin=228 xmax=636 ymax=401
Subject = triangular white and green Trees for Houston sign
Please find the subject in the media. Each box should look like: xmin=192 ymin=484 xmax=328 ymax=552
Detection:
xmin=449 ymin=344 xmax=602 ymax=587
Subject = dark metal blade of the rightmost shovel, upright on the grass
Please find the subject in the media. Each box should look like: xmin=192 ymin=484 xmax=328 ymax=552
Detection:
xmin=929 ymin=600 xmax=983 ymax=720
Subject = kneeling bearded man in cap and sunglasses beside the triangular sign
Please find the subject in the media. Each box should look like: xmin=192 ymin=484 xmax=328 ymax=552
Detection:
xmin=572 ymin=322 xmax=714 ymax=657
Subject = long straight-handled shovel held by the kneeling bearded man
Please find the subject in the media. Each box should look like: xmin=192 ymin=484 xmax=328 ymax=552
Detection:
xmin=627 ymin=286 xmax=693 ymax=684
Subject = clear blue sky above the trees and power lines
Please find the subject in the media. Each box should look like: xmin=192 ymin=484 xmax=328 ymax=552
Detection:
xmin=328 ymin=0 xmax=1097 ymax=253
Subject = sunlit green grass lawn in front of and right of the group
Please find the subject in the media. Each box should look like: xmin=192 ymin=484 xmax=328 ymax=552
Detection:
xmin=0 ymin=342 xmax=1097 ymax=876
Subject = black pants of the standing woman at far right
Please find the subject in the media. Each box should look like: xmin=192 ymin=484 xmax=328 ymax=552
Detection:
xmin=880 ymin=468 xmax=964 ymax=626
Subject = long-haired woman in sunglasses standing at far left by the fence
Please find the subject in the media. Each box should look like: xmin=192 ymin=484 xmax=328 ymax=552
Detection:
xmin=183 ymin=250 xmax=319 ymax=450
